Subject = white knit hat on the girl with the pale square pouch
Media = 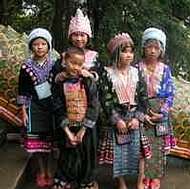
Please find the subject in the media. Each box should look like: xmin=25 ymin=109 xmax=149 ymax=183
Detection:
xmin=28 ymin=28 xmax=52 ymax=50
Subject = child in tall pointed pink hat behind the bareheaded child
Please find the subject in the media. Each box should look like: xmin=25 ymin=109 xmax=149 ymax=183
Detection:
xmin=55 ymin=9 xmax=99 ymax=81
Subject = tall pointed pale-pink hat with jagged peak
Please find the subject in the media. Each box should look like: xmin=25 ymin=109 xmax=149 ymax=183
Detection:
xmin=68 ymin=8 xmax=92 ymax=38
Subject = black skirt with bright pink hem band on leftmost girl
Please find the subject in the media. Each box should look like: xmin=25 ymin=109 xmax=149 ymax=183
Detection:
xmin=21 ymin=99 xmax=53 ymax=153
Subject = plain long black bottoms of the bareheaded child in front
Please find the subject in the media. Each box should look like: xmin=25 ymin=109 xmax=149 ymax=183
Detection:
xmin=56 ymin=127 xmax=97 ymax=185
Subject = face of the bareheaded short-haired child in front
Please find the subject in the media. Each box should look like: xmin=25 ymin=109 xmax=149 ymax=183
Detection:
xmin=65 ymin=54 xmax=85 ymax=76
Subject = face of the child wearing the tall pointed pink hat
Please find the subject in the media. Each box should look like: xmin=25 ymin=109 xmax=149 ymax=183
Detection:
xmin=71 ymin=32 xmax=88 ymax=48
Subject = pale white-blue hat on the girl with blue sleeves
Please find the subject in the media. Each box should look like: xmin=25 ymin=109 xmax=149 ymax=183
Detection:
xmin=142 ymin=27 xmax=166 ymax=52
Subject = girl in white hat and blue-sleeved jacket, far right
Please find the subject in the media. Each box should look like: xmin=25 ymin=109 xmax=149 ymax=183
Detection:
xmin=138 ymin=28 xmax=175 ymax=189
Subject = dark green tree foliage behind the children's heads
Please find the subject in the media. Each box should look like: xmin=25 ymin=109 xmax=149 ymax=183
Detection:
xmin=0 ymin=0 xmax=190 ymax=80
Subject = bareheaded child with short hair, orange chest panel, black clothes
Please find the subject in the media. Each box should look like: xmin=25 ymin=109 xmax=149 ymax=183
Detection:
xmin=52 ymin=47 xmax=99 ymax=189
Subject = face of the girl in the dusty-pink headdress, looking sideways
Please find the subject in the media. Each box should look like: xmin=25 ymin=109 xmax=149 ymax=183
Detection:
xmin=119 ymin=47 xmax=134 ymax=65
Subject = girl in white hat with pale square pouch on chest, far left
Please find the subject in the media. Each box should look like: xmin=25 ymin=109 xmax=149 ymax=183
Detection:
xmin=18 ymin=28 xmax=53 ymax=187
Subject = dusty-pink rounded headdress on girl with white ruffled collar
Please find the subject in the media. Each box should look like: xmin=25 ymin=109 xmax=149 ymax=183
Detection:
xmin=107 ymin=33 xmax=133 ymax=54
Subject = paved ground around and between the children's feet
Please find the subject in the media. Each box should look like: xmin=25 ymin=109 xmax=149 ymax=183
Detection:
xmin=0 ymin=143 xmax=190 ymax=189
